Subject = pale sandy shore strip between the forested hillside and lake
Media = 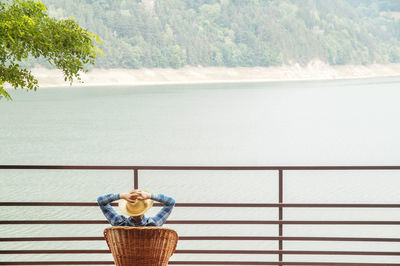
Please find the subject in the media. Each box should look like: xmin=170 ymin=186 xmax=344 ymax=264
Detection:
xmin=20 ymin=60 xmax=400 ymax=87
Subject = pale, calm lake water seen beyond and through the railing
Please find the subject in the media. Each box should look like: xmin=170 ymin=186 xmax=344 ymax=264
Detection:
xmin=0 ymin=77 xmax=400 ymax=263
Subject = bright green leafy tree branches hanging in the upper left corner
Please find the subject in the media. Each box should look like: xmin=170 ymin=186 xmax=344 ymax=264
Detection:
xmin=0 ymin=0 xmax=101 ymax=99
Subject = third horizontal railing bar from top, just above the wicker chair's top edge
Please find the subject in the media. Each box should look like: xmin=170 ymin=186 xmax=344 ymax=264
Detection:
xmin=0 ymin=220 xmax=400 ymax=225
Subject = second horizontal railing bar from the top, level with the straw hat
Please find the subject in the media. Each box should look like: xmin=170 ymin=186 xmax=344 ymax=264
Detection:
xmin=0 ymin=202 xmax=400 ymax=208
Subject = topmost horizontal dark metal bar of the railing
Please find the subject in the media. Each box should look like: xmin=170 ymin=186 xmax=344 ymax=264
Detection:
xmin=0 ymin=165 xmax=400 ymax=170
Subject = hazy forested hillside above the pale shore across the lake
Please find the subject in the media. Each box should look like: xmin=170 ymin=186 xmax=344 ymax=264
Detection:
xmin=34 ymin=0 xmax=400 ymax=68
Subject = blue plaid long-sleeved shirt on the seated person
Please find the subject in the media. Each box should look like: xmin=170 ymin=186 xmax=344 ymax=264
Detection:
xmin=97 ymin=194 xmax=175 ymax=226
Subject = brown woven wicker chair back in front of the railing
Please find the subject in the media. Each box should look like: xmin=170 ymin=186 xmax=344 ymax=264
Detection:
xmin=104 ymin=226 xmax=178 ymax=266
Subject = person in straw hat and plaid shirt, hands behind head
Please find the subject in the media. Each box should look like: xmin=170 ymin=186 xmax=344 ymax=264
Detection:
xmin=97 ymin=189 xmax=175 ymax=226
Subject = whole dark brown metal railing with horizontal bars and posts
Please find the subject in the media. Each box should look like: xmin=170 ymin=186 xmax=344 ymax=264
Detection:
xmin=0 ymin=165 xmax=400 ymax=265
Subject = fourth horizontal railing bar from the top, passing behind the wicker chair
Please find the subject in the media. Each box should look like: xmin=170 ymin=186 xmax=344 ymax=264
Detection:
xmin=0 ymin=236 xmax=400 ymax=242
